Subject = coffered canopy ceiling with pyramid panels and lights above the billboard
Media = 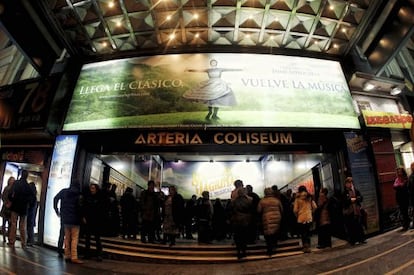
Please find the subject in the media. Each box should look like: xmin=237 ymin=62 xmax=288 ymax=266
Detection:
xmin=38 ymin=0 xmax=381 ymax=57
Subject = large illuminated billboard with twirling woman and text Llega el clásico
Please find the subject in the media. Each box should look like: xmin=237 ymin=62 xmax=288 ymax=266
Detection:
xmin=63 ymin=53 xmax=360 ymax=131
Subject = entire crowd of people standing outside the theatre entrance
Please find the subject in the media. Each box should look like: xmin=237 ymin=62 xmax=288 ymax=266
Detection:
xmin=8 ymin=164 xmax=414 ymax=263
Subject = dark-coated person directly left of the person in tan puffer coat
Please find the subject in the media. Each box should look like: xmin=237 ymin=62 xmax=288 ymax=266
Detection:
xmin=231 ymin=188 xmax=252 ymax=259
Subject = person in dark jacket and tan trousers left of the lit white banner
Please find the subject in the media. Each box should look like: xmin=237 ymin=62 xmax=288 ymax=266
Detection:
xmin=7 ymin=170 xmax=32 ymax=248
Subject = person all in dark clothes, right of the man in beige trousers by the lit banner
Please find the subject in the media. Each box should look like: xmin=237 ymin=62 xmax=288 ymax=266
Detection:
xmin=82 ymin=183 xmax=109 ymax=261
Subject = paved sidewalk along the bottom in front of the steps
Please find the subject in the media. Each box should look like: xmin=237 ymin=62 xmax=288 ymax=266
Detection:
xmin=0 ymin=230 xmax=408 ymax=275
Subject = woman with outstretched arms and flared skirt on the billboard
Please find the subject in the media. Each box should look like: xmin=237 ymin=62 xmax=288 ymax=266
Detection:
xmin=183 ymin=59 xmax=241 ymax=120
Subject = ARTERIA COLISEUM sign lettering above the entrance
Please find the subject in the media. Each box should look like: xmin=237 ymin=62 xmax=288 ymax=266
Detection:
xmin=135 ymin=132 xmax=293 ymax=145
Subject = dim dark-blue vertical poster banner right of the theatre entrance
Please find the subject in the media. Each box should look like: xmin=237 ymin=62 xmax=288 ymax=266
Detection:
xmin=344 ymin=132 xmax=379 ymax=234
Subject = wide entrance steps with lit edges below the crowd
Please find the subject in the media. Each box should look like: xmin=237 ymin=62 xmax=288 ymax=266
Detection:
xmin=79 ymin=237 xmax=303 ymax=263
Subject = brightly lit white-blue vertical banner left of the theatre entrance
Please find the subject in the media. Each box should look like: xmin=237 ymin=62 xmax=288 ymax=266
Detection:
xmin=43 ymin=135 xmax=78 ymax=247
